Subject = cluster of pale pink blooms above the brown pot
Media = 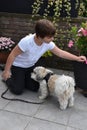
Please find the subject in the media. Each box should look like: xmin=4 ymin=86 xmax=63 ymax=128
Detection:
xmin=0 ymin=37 xmax=15 ymax=52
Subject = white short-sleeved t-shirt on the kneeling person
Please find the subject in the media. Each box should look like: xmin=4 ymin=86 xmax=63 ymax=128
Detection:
xmin=13 ymin=34 xmax=55 ymax=68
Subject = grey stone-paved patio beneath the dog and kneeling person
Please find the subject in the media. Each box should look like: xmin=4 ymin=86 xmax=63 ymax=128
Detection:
xmin=0 ymin=69 xmax=87 ymax=130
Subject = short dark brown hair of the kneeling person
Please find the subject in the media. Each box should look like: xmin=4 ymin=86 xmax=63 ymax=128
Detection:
xmin=35 ymin=19 xmax=56 ymax=38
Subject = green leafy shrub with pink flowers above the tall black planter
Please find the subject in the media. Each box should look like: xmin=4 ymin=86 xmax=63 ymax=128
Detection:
xmin=68 ymin=22 xmax=87 ymax=56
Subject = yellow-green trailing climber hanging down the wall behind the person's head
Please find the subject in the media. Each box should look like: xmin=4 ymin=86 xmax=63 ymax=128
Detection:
xmin=32 ymin=0 xmax=84 ymax=55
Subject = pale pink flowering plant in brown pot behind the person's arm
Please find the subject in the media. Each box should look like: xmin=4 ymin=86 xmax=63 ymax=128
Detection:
xmin=0 ymin=37 xmax=15 ymax=64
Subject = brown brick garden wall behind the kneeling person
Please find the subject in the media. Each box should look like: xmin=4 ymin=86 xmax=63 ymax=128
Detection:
xmin=0 ymin=12 xmax=87 ymax=70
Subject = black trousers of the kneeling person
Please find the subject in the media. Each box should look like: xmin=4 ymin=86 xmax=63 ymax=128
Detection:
xmin=6 ymin=66 xmax=39 ymax=95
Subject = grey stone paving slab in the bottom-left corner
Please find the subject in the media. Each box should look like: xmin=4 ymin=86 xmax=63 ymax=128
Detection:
xmin=0 ymin=110 xmax=31 ymax=130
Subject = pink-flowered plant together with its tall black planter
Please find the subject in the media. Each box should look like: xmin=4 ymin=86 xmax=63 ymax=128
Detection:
xmin=68 ymin=22 xmax=87 ymax=96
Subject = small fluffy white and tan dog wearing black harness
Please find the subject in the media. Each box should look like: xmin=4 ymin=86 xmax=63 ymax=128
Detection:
xmin=31 ymin=66 xmax=75 ymax=110
